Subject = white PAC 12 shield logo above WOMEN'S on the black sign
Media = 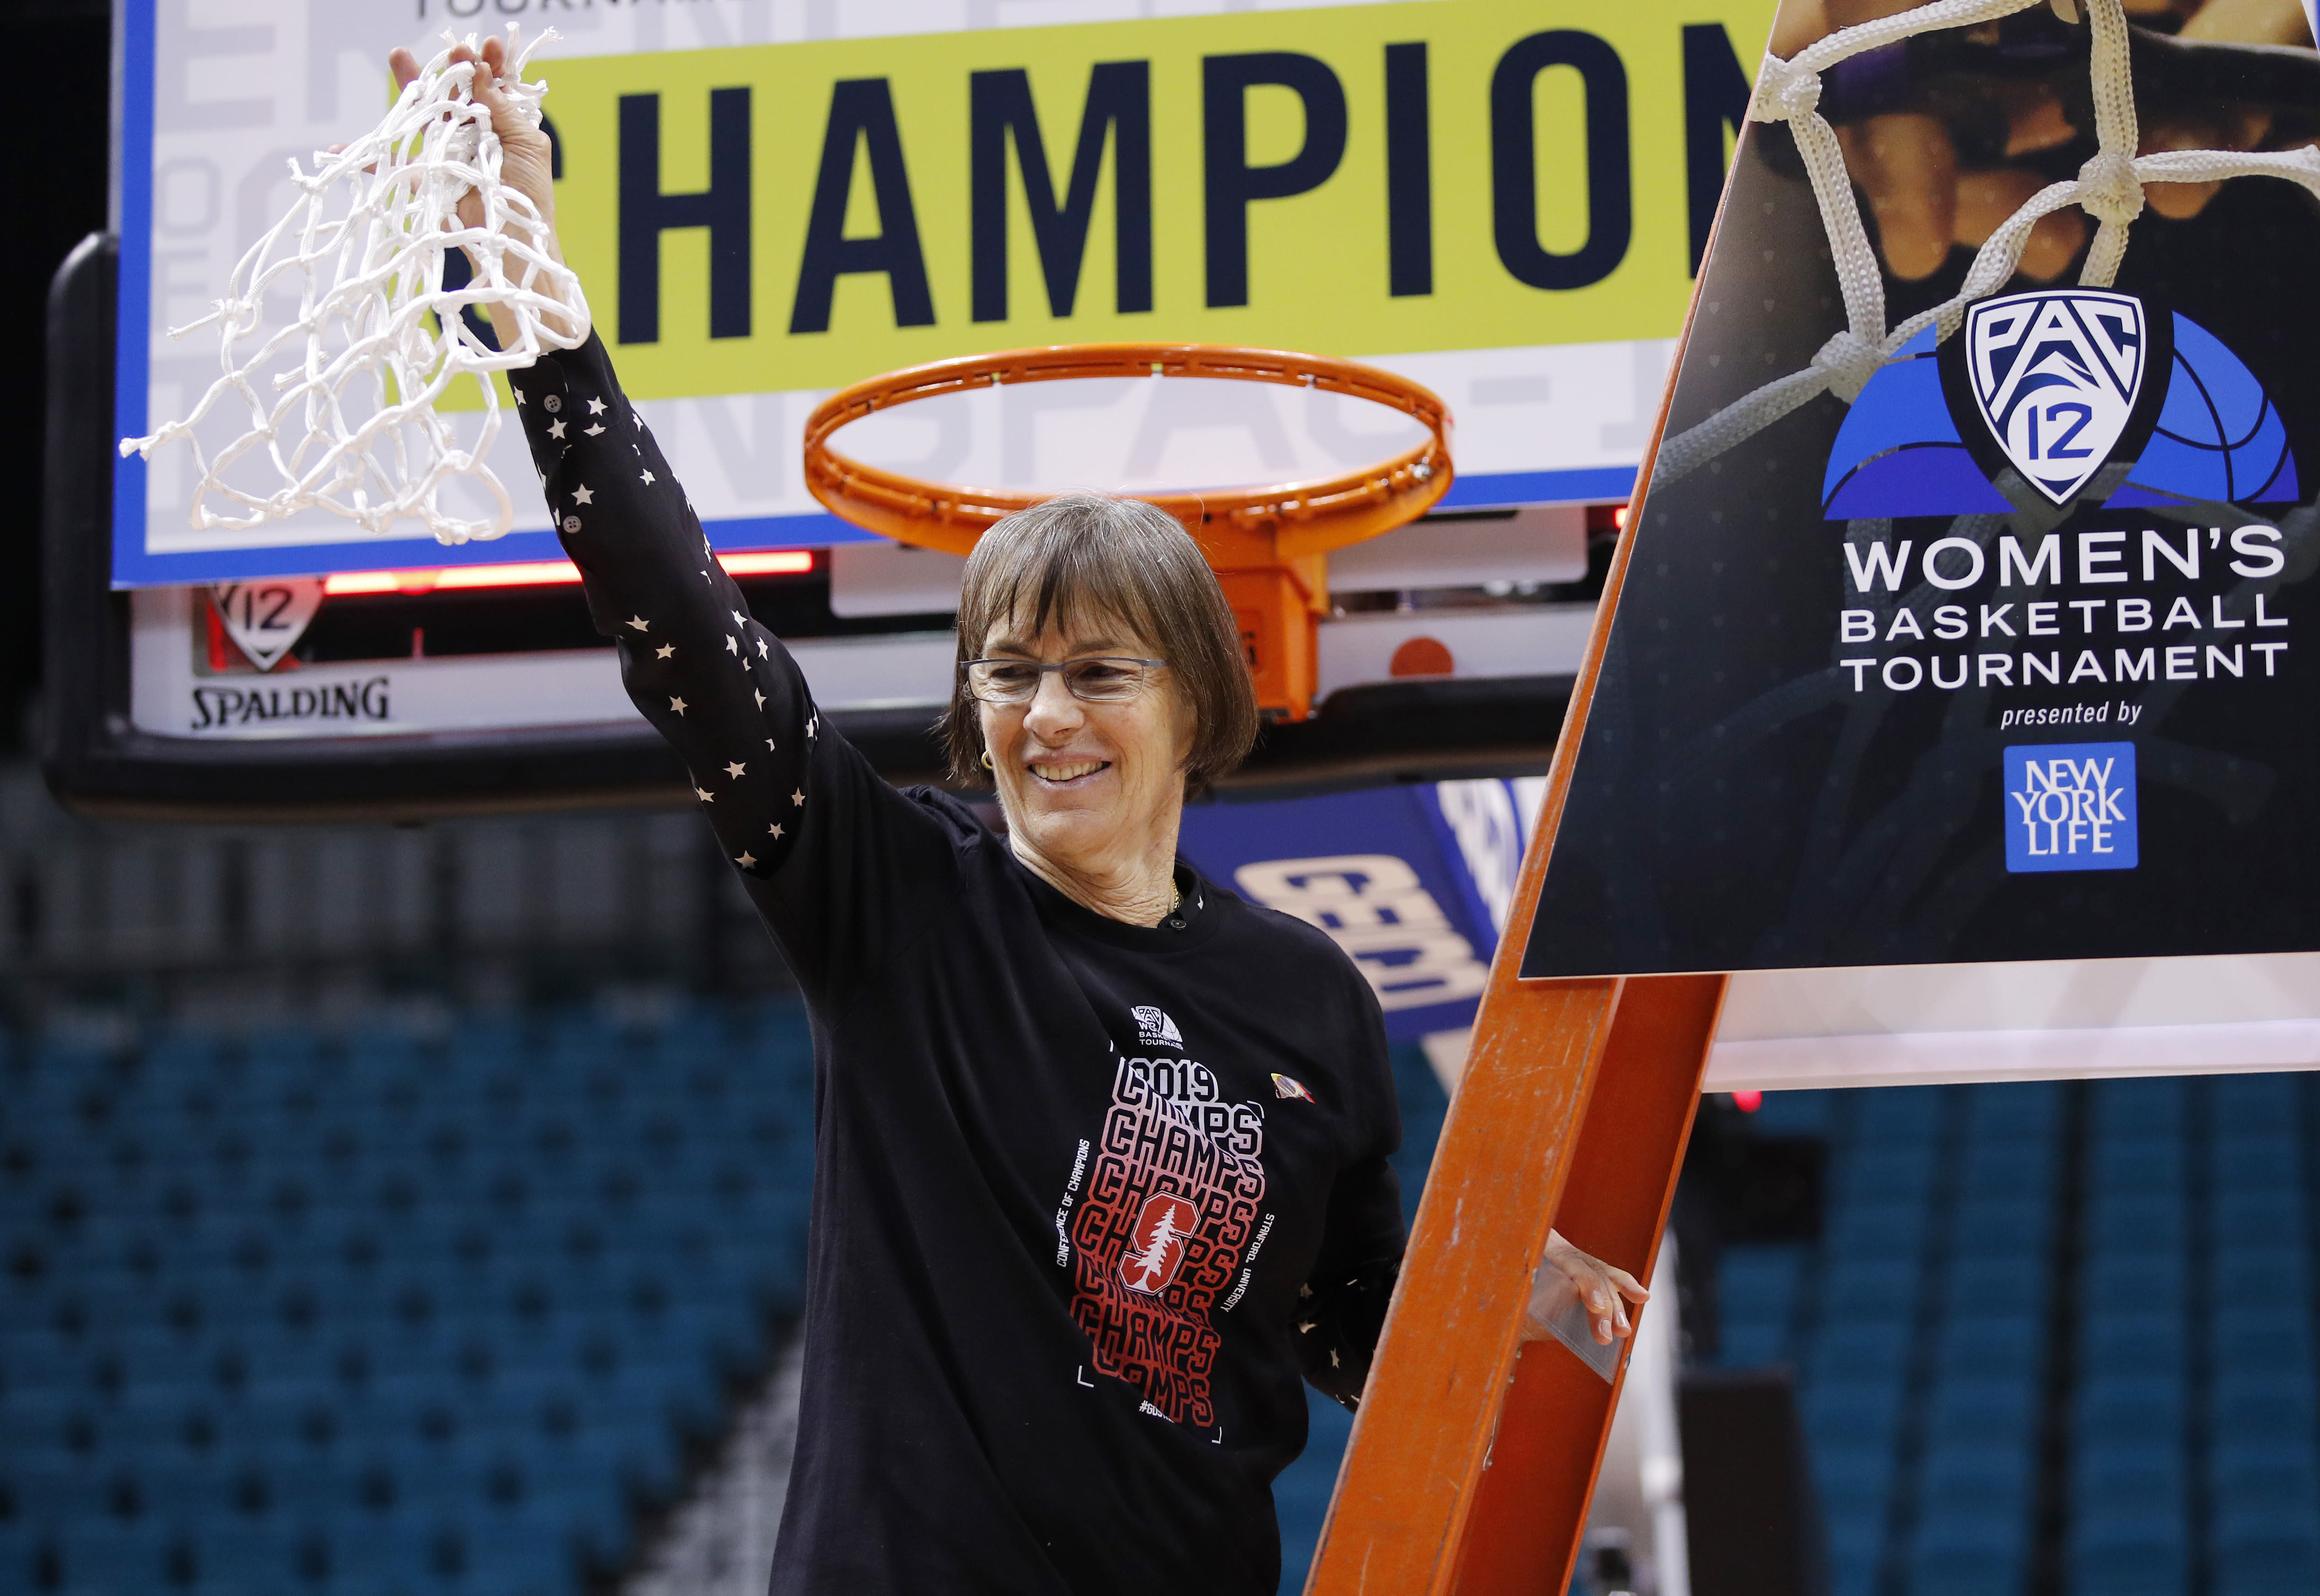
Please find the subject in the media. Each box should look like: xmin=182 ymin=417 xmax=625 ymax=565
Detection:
xmin=1965 ymin=288 xmax=2148 ymax=503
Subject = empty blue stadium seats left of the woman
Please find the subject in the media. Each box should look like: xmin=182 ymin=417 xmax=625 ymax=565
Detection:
xmin=0 ymin=1007 xmax=812 ymax=1596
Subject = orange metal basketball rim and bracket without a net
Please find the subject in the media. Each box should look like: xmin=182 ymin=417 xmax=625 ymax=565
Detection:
xmin=805 ymin=343 xmax=1450 ymax=719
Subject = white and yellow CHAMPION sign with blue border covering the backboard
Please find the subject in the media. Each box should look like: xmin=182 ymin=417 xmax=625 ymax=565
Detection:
xmin=113 ymin=0 xmax=1772 ymax=585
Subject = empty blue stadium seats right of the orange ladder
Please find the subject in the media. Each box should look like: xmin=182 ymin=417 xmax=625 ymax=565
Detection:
xmin=1719 ymin=1074 xmax=2320 ymax=1596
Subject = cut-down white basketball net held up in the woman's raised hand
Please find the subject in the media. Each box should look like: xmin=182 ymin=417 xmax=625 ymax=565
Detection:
xmin=121 ymin=28 xmax=587 ymax=543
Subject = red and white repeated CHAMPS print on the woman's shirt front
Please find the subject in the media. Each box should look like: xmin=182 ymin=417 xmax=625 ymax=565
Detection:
xmin=1072 ymin=1058 xmax=1264 ymax=1427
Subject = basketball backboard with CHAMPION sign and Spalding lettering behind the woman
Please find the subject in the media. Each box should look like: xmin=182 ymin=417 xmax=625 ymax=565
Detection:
xmin=46 ymin=0 xmax=1770 ymax=814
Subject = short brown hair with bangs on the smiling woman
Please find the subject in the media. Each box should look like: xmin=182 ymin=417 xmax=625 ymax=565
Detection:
xmin=942 ymin=494 xmax=1257 ymax=791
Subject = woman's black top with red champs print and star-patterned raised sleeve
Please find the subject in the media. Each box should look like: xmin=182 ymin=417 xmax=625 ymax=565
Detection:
xmin=515 ymin=336 xmax=1403 ymax=1596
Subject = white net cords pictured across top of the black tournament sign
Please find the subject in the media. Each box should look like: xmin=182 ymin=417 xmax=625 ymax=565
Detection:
xmin=1652 ymin=0 xmax=2320 ymax=483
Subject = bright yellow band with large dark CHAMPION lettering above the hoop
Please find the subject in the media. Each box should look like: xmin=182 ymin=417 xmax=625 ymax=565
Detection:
xmin=522 ymin=0 xmax=1772 ymax=397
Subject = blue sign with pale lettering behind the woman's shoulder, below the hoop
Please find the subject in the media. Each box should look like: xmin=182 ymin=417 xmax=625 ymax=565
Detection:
xmin=1181 ymin=782 xmax=1536 ymax=1041
